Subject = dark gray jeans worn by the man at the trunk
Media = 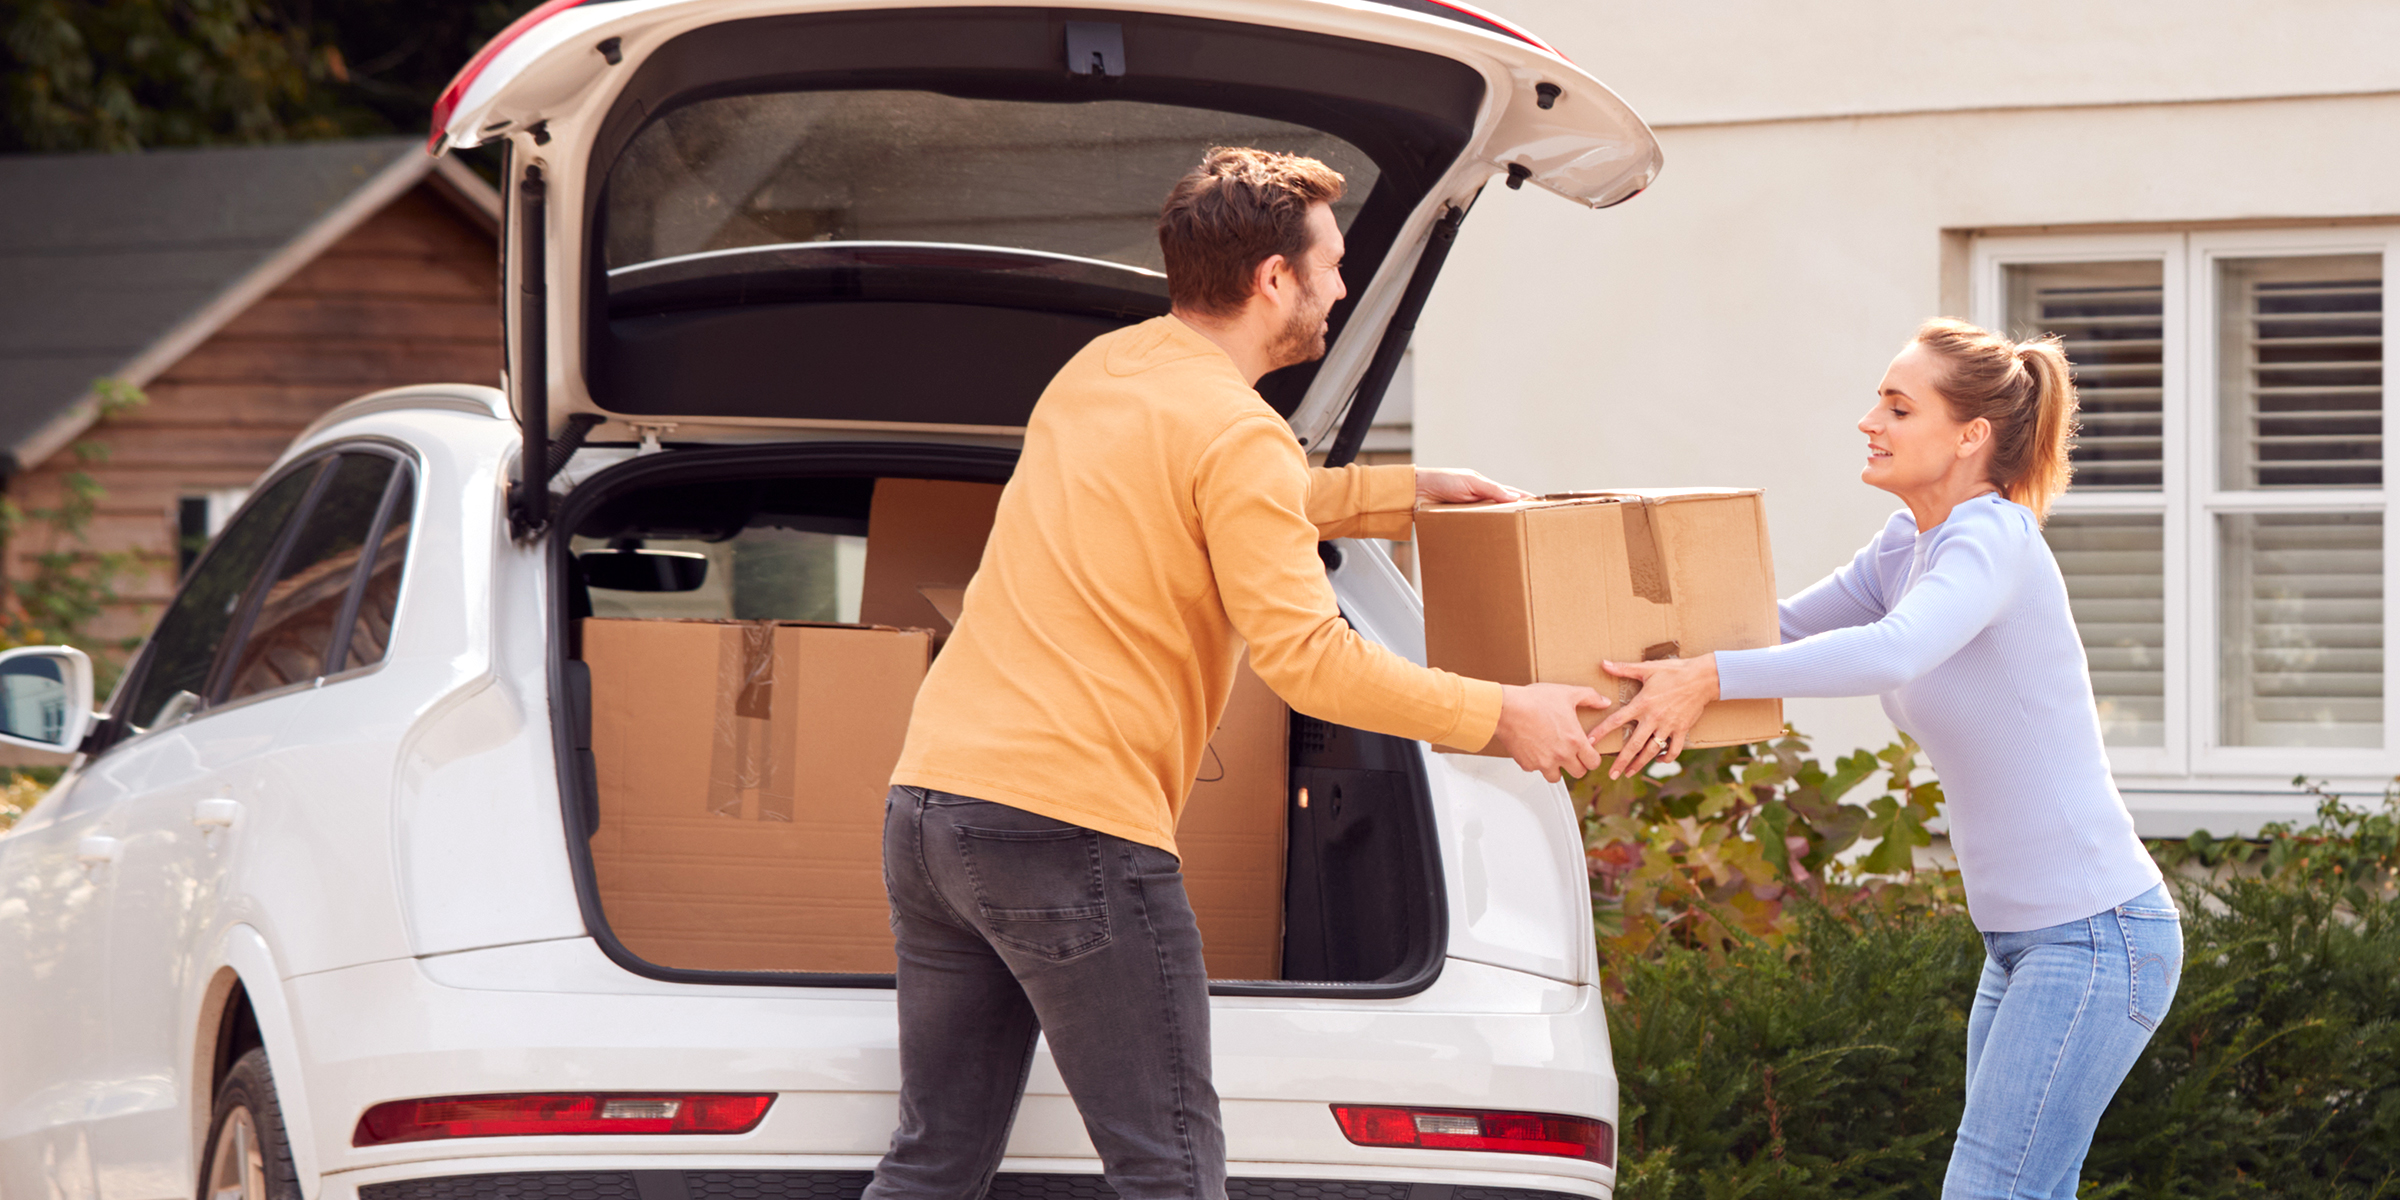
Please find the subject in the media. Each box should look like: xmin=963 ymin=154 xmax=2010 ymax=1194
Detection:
xmin=862 ymin=787 xmax=1224 ymax=1200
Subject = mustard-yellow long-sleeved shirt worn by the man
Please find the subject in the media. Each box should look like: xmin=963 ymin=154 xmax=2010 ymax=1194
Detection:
xmin=893 ymin=317 xmax=1500 ymax=852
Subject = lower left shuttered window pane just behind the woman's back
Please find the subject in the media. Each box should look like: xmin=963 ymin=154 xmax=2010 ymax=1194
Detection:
xmin=2042 ymin=514 xmax=2167 ymax=746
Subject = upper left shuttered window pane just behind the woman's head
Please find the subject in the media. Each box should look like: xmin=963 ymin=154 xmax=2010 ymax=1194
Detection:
xmin=2009 ymin=262 xmax=2167 ymax=492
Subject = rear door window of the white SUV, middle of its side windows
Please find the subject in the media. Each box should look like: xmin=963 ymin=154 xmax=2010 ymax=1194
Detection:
xmin=226 ymin=454 xmax=398 ymax=701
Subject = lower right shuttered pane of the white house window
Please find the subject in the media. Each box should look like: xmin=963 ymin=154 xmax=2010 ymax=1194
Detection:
xmin=2218 ymin=514 xmax=2383 ymax=749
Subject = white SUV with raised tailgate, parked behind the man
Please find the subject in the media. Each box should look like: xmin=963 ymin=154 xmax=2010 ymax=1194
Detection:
xmin=0 ymin=0 xmax=1658 ymax=1200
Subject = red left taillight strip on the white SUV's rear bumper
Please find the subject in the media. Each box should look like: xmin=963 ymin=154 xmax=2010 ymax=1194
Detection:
xmin=350 ymin=1092 xmax=775 ymax=1145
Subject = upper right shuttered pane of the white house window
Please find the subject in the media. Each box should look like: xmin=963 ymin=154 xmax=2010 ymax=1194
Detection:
xmin=2218 ymin=254 xmax=2383 ymax=490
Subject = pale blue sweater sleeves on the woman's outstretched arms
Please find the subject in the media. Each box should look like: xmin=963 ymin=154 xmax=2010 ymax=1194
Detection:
xmin=1716 ymin=508 xmax=2030 ymax=701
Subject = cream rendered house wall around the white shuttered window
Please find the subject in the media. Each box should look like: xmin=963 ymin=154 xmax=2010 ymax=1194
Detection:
xmin=1414 ymin=0 xmax=2400 ymax=833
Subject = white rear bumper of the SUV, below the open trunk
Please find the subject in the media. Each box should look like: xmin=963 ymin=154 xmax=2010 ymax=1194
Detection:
xmin=290 ymin=938 xmax=1618 ymax=1200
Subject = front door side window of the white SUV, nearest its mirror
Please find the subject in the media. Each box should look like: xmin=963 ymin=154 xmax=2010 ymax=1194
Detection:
xmin=120 ymin=463 xmax=324 ymax=730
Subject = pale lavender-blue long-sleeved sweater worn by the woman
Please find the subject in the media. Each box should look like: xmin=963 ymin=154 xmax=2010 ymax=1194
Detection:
xmin=1716 ymin=494 xmax=2160 ymax=934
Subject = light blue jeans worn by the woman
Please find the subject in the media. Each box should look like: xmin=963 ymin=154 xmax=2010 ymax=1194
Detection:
xmin=1942 ymin=883 xmax=2184 ymax=1200
